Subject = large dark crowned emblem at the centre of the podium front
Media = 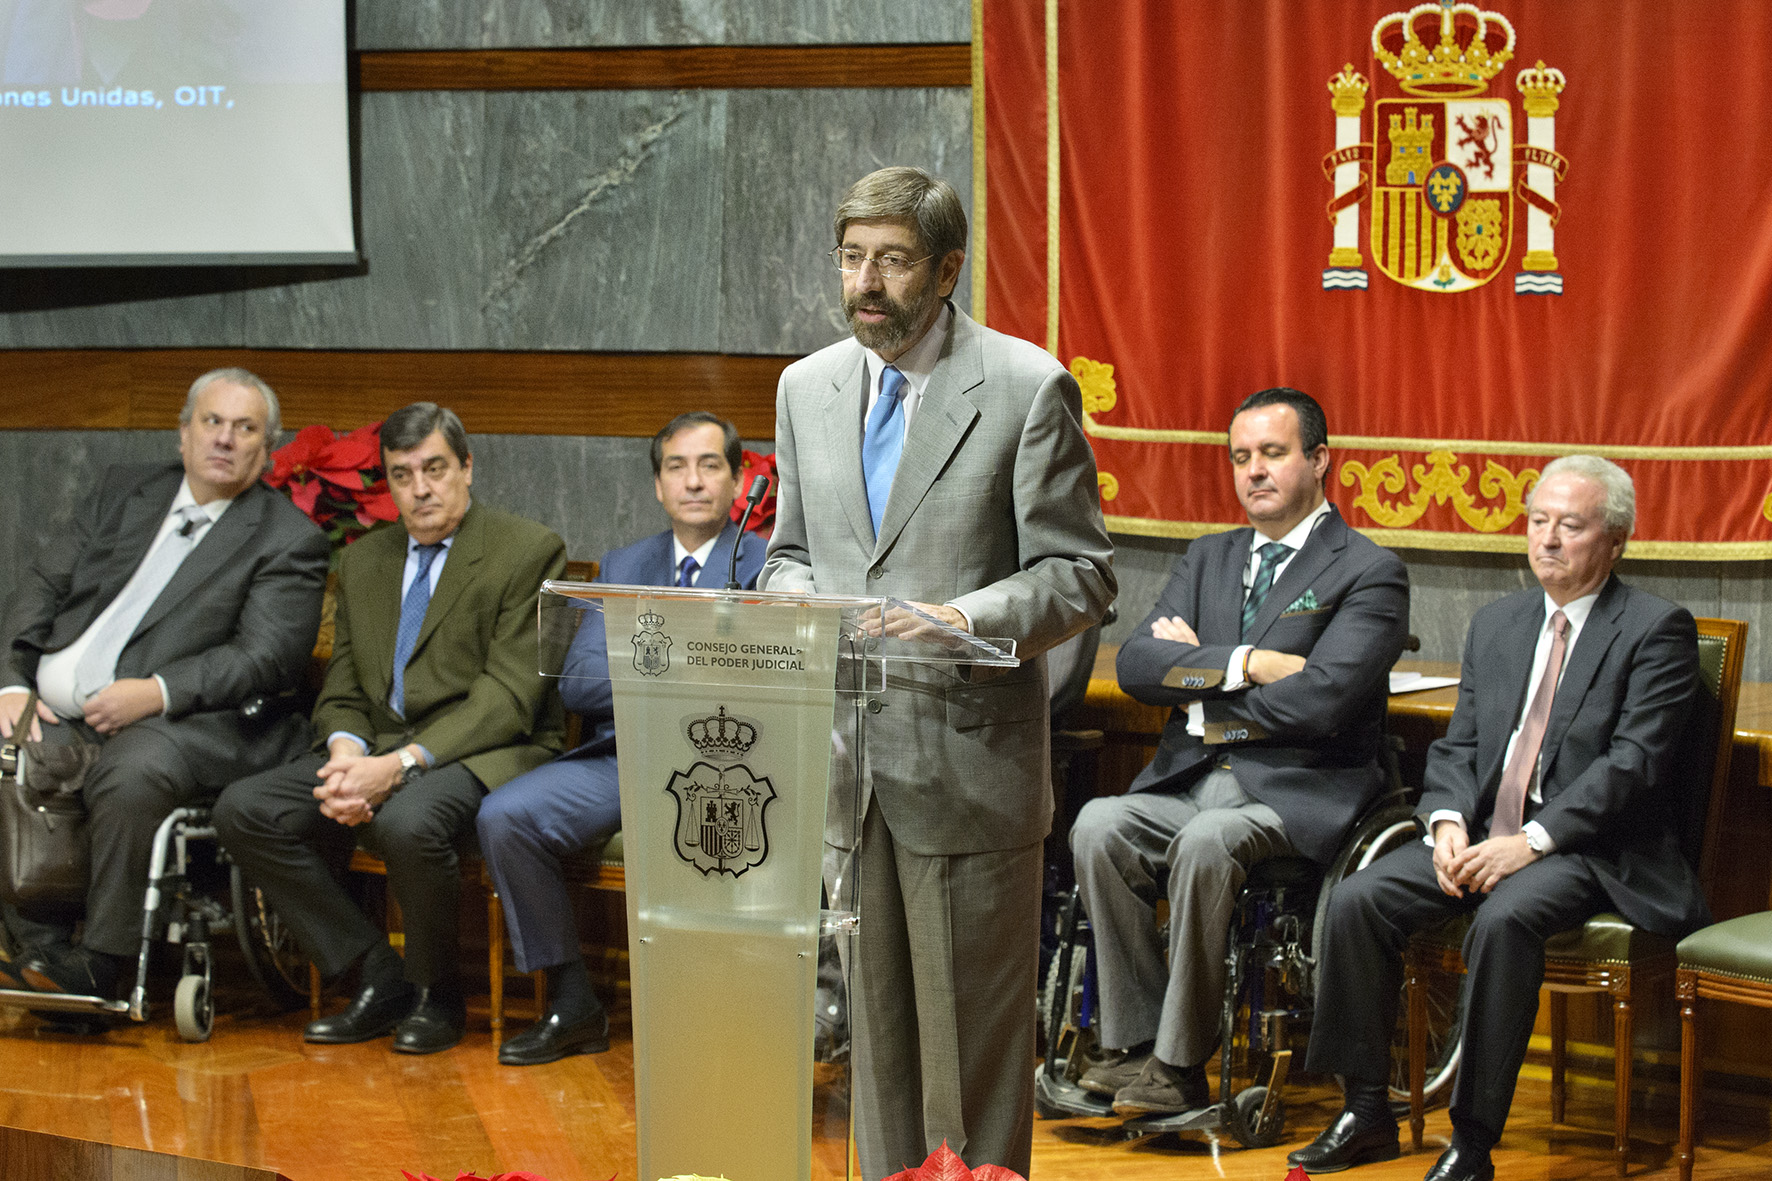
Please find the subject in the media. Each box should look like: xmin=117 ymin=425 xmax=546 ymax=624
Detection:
xmin=665 ymin=706 xmax=776 ymax=878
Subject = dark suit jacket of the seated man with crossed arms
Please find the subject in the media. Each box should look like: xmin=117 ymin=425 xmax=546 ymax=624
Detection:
xmin=1116 ymin=507 xmax=1409 ymax=862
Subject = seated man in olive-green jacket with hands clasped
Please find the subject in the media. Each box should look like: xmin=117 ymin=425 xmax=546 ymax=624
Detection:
xmin=214 ymin=403 xmax=565 ymax=1053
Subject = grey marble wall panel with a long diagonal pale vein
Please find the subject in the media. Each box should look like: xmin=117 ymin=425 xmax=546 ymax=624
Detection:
xmin=468 ymin=90 xmax=728 ymax=351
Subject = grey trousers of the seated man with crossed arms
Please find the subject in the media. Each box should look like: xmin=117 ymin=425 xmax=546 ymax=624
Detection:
xmin=1070 ymin=770 xmax=1292 ymax=1066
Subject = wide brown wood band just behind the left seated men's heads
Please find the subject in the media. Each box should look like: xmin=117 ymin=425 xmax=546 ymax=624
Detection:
xmin=0 ymin=349 xmax=794 ymax=438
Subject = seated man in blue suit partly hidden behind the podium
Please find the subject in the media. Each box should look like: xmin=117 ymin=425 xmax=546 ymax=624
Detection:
xmin=478 ymin=411 xmax=764 ymax=1066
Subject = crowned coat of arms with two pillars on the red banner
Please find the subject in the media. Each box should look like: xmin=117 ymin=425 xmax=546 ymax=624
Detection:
xmin=1324 ymin=0 xmax=1568 ymax=294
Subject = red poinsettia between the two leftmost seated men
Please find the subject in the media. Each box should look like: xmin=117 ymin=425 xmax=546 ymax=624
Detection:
xmin=264 ymin=422 xmax=400 ymax=564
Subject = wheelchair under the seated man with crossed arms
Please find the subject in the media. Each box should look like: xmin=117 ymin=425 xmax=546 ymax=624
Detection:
xmin=1035 ymin=773 xmax=1464 ymax=1147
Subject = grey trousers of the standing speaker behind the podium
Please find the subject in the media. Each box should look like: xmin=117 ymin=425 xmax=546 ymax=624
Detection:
xmin=851 ymin=790 xmax=1042 ymax=1181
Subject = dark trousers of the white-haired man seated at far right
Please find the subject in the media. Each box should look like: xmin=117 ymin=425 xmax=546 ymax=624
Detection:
xmin=1308 ymin=842 xmax=1607 ymax=1140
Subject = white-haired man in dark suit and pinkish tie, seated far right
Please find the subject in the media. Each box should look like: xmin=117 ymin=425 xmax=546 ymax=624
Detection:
xmin=1292 ymin=456 xmax=1710 ymax=1181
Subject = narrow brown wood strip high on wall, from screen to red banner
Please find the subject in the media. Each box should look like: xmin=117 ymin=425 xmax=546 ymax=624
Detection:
xmin=358 ymin=44 xmax=973 ymax=90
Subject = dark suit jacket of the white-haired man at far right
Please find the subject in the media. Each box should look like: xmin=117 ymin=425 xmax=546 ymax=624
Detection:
xmin=1421 ymin=575 xmax=1710 ymax=936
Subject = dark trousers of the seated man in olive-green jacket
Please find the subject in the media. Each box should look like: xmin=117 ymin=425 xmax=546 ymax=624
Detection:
xmin=214 ymin=755 xmax=484 ymax=984
